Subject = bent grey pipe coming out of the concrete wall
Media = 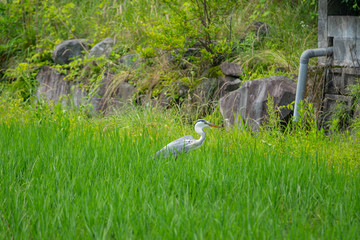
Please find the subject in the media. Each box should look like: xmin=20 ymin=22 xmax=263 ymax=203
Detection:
xmin=294 ymin=47 xmax=333 ymax=122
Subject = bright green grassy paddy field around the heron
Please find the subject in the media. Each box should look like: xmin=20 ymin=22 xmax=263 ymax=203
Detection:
xmin=0 ymin=101 xmax=360 ymax=239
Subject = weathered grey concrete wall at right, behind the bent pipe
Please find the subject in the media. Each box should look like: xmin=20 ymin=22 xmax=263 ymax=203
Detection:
xmin=318 ymin=0 xmax=360 ymax=125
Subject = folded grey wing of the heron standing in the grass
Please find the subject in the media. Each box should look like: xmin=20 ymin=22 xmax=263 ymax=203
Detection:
xmin=156 ymin=135 xmax=195 ymax=157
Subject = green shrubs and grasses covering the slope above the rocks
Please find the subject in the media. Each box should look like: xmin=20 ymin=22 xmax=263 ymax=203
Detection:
xmin=0 ymin=0 xmax=317 ymax=101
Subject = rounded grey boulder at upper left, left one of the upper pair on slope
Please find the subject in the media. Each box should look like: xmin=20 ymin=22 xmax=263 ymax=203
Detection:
xmin=52 ymin=39 xmax=89 ymax=65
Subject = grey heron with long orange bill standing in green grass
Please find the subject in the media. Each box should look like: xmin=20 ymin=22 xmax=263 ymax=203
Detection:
xmin=155 ymin=119 xmax=222 ymax=158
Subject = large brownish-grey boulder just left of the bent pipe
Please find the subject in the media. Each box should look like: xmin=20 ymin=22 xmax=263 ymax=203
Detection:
xmin=219 ymin=76 xmax=296 ymax=130
